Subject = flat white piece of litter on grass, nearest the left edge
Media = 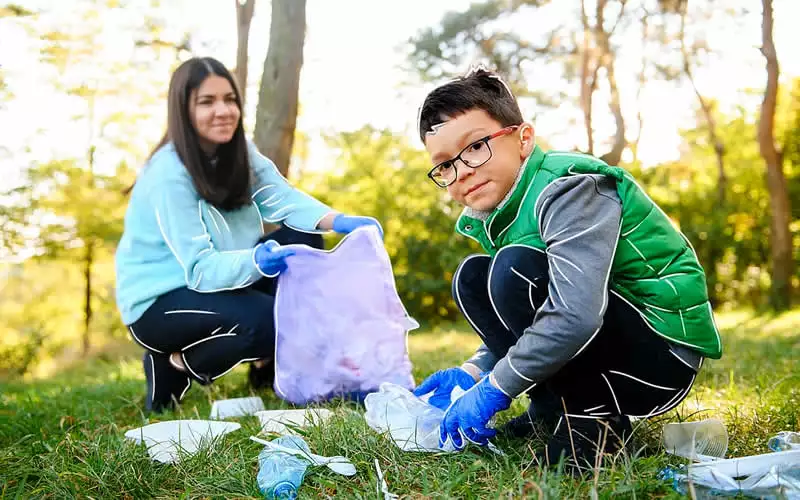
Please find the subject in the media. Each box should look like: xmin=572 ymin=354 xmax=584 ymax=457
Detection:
xmin=125 ymin=420 xmax=241 ymax=464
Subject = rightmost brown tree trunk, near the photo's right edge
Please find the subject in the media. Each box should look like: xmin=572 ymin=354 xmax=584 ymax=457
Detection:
xmin=758 ymin=0 xmax=793 ymax=311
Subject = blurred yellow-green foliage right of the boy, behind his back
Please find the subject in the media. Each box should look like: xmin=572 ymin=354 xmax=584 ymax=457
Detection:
xmin=632 ymin=81 xmax=800 ymax=308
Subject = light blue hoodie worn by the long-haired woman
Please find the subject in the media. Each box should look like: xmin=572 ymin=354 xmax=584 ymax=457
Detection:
xmin=116 ymin=142 xmax=333 ymax=325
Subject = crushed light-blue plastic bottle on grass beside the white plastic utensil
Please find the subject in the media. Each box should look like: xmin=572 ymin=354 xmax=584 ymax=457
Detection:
xmin=256 ymin=436 xmax=311 ymax=500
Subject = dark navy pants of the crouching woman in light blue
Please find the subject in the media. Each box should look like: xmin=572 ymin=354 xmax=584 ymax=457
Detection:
xmin=128 ymin=227 xmax=323 ymax=407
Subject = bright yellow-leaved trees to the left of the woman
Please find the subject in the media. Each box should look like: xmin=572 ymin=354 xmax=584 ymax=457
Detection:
xmin=0 ymin=0 xmax=178 ymax=373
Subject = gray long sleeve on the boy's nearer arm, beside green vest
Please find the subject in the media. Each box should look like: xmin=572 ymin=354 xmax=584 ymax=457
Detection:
xmin=494 ymin=175 xmax=622 ymax=397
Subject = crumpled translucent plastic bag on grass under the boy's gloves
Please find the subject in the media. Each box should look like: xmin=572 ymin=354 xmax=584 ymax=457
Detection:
xmin=364 ymin=383 xmax=503 ymax=455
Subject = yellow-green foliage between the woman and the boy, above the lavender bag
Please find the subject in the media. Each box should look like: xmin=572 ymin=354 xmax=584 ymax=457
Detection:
xmin=303 ymin=127 xmax=477 ymax=321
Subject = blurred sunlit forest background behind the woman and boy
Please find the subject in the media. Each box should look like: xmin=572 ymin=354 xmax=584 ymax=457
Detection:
xmin=0 ymin=0 xmax=800 ymax=377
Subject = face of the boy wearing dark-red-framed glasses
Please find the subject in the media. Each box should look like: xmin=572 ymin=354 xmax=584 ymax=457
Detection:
xmin=425 ymin=109 xmax=534 ymax=211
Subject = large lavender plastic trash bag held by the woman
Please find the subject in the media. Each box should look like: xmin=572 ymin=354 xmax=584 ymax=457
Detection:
xmin=274 ymin=227 xmax=419 ymax=405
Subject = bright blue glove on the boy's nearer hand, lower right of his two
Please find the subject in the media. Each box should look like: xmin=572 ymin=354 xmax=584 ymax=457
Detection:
xmin=439 ymin=375 xmax=511 ymax=450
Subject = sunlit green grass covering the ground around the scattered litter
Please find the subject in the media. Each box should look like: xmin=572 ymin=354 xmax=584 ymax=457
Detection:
xmin=0 ymin=311 xmax=800 ymax=499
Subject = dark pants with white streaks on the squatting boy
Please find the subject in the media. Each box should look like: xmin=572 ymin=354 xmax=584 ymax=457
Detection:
xmin=453 ymin=246 xmax=696 ymax=426
